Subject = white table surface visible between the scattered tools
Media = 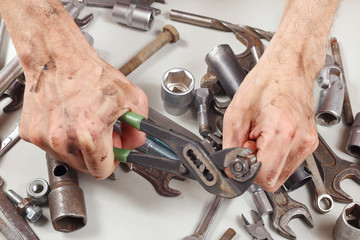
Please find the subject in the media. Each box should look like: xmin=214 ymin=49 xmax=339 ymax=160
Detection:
xmin=0 ymin=0 xmax=360 ymax=239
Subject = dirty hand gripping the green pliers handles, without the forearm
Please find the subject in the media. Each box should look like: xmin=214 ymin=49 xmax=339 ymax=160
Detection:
xmin=20 ymin=48 xmax=148 ymax=179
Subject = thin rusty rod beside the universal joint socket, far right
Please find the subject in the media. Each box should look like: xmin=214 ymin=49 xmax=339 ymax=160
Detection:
xmin=330 ymin=37 xmax=354 ymax=126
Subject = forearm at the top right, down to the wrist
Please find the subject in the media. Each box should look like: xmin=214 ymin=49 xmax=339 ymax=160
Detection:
xmin=265 ymin=0 xmax=340 ymax=85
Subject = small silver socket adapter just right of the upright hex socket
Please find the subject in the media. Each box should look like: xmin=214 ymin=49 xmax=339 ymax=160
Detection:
xmin=193 ymin=88 xmax=212 ymax=137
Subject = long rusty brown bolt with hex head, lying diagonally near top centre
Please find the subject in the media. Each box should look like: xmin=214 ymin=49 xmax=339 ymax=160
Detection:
xmin=119 ymin=25 xmax=180 ymax=76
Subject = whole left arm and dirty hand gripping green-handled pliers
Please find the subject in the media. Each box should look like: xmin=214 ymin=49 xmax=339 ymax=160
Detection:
xmin=0 ymin=0 xmax=148 ymax=179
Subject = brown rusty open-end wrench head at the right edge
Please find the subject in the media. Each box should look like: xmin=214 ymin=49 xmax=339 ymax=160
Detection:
xmin=313 ymin=134 xmax=360 ymax=203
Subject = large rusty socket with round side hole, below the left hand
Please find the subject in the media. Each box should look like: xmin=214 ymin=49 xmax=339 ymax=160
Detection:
xmin=46 ymin=153 xmax=87 ymax=232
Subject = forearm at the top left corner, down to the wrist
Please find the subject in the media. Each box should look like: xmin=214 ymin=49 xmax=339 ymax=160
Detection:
xmin=0 ymin=0 xmax=95 ymax=78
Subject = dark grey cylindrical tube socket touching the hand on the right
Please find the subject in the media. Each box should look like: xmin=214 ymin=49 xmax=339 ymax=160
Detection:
xmin=205 ymin=44 xmax=246 ymax=98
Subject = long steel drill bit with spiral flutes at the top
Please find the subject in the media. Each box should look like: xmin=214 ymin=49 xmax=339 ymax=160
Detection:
xmin=170 ymin=9 xmax=274 ymax=41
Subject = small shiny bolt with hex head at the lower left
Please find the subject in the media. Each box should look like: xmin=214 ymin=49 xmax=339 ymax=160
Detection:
xmin=5 ymin=189 xmax=42 ymax=223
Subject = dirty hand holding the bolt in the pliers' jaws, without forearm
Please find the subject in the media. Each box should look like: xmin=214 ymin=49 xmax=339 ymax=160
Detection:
xmin=224 ymin=50 xmax=317 ymax=191
